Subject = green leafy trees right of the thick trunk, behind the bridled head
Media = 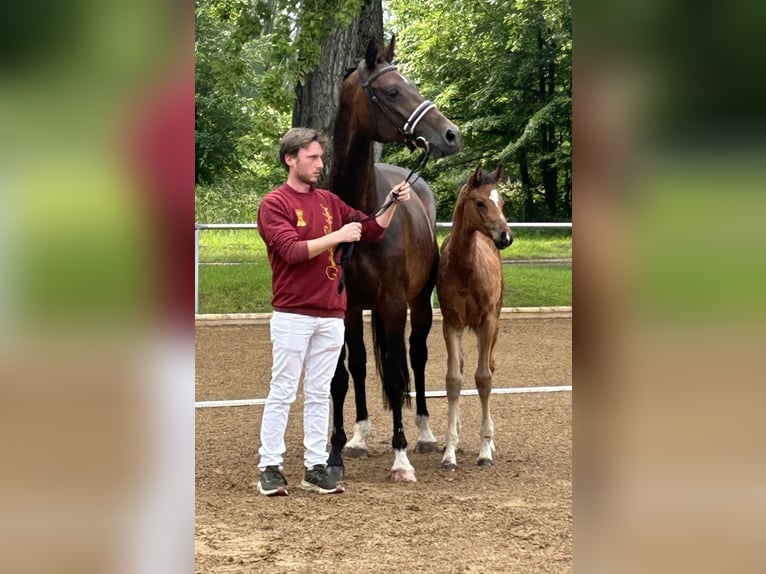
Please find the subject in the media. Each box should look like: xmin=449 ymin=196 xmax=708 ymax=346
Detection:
xmin=384 ymin=0 xmax=572 ymax=221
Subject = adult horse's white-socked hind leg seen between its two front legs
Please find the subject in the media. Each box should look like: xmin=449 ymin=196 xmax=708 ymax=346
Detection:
xmin=343 ymin=309 xmax=372 ymax=457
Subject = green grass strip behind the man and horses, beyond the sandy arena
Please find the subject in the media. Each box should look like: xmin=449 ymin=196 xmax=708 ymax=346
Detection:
xmin=199 ymin=224 xmax=572 ymax=313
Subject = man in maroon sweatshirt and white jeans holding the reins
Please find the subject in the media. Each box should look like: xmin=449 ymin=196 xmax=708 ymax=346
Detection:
xmin=258 ymin=128 xmax=410 ymax=496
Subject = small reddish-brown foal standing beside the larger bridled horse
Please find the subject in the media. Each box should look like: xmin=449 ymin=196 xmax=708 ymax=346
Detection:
xmin=436 ymin=165 xmax=513 ymax=470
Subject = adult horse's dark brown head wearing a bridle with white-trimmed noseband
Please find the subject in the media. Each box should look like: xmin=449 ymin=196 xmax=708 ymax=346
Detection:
xmin=344 ymin=36 xmax=462 ymax=157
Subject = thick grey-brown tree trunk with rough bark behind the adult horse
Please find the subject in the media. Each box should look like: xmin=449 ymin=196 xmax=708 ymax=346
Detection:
xmin=292 ymin=0 xmax=384 ymax=183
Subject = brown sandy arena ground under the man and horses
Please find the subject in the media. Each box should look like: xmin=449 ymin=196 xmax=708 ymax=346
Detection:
xmin=196 ymin=314 xmax=572 ymax=574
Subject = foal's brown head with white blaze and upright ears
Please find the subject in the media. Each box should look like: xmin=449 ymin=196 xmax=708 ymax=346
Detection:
xmin=455 ymin=164 xmax=513 ymax=249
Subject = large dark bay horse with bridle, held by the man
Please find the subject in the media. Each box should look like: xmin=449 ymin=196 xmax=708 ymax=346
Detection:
xmin=327 ymin=37 xmax=461 ymax=482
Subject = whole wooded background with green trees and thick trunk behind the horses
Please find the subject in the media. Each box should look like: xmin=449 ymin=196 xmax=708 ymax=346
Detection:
xmin=195 ymin=0 xmax=572 ymax=223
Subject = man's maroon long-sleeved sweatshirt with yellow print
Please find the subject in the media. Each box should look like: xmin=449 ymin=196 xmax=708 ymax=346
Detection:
xmin=258 ymin=183 xmax=386 ymax=317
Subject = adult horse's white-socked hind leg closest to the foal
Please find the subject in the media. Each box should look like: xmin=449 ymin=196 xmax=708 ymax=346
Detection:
xmin=410 ymin=288 xmax=439 ymax=453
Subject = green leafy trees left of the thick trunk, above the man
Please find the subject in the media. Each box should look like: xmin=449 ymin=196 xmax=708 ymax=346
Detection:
xmin=195 ymin=0 xmax=362 ymax=184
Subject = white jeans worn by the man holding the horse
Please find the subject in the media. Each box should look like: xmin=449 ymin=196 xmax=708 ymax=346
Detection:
xmin=258 ymin=311 xmax=344 ymax=470
